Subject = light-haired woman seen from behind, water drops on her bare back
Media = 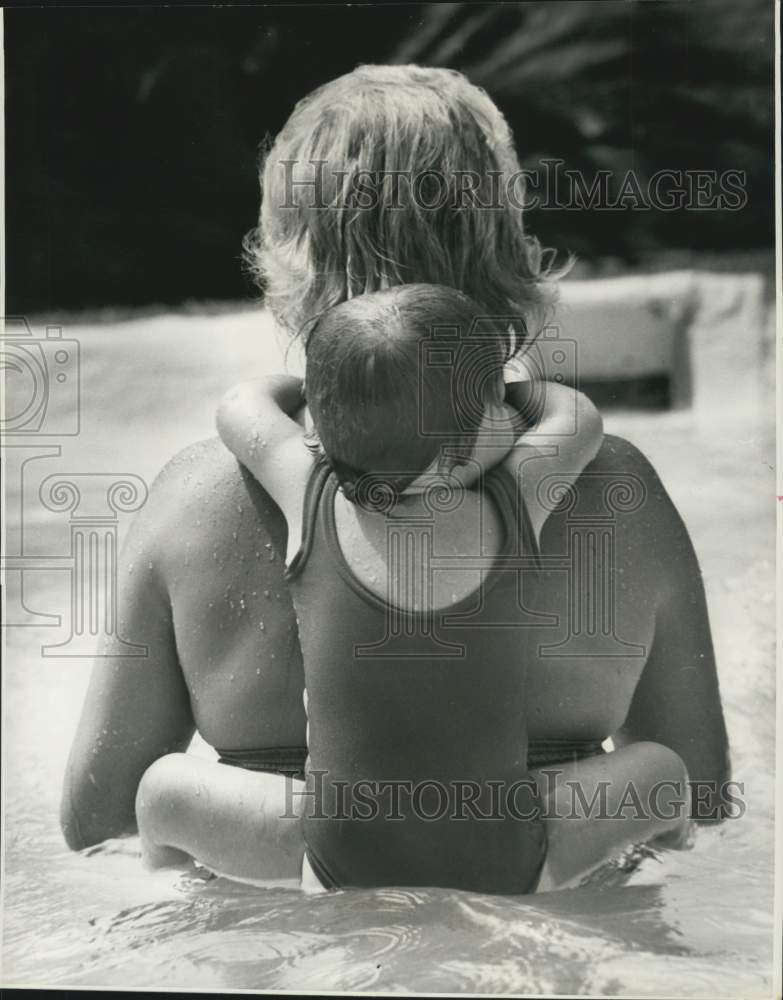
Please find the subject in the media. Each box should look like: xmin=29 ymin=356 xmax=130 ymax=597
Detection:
xmin=62 ymin=67 xmax=728 ymax=888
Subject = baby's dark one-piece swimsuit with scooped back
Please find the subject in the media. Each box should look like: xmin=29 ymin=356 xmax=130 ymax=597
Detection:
xmin=288 ymin=462 xmax=546 ymax=894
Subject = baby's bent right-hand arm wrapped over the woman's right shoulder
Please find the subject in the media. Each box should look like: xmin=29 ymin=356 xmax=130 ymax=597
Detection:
xmin=506 ymin=382 xmax=603 ymax=539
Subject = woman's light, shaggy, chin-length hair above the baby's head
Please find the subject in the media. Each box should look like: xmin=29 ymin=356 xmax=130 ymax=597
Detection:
xmin=245 ymin=65 xmax=567 ymax=348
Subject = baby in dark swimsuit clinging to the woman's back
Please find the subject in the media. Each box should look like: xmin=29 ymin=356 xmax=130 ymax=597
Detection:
xmin=140 ymin=285 xmax=602 ymax=893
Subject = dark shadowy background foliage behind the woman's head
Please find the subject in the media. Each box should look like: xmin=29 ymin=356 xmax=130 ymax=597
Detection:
xmin=5 ymin=0 xmax=774 ymax=312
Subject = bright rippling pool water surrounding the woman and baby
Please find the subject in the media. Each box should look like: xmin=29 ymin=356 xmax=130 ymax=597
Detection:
xmin=3 ymin=319 xmax=775 ymax=998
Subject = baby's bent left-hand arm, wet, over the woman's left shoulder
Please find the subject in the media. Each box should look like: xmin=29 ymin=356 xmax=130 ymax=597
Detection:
xmin=217 ymin=375 xmax=312 ymax=562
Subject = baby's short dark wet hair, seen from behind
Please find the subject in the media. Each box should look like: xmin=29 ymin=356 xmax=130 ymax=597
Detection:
xmin=305 ymin=284 xmax=516 ymax=509
